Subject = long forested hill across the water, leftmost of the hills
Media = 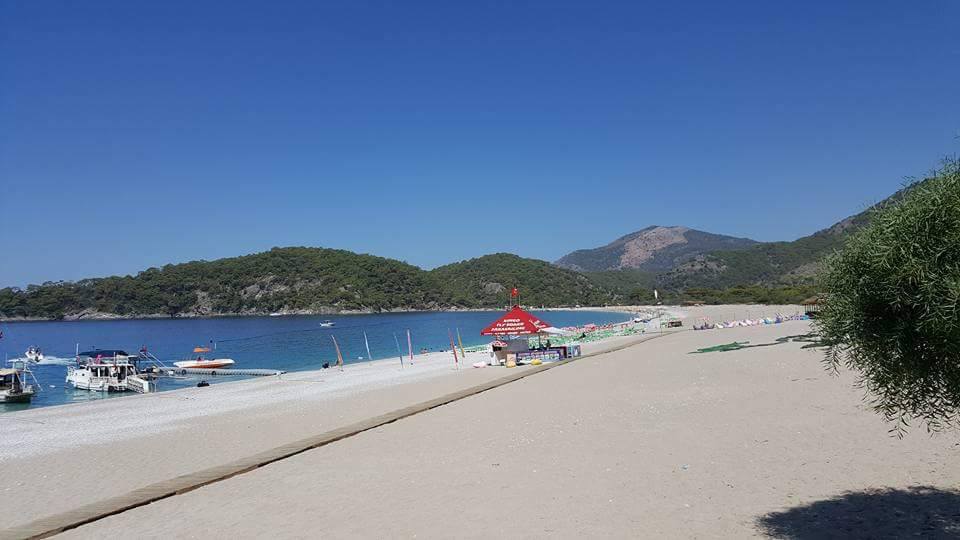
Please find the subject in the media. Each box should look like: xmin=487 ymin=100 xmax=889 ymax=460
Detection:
xmin=0 ymin=247 xmax=438 ymax=318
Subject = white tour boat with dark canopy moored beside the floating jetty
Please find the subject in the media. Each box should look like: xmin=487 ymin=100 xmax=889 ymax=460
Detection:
xmin=66 ymin=349 xmax=156 ymax=393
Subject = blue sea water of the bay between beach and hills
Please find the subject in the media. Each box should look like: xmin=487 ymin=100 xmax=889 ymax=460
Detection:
xmin=0 ymin=311 xmax=629 ymax=412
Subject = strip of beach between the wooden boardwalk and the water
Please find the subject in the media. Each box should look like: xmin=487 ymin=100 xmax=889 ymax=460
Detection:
xmin=0 ymin=326 xmax=652 ymax=529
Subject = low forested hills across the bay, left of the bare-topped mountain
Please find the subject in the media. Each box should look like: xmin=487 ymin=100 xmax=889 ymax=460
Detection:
xmin=0 ymin=247 xmax=610 ymax=319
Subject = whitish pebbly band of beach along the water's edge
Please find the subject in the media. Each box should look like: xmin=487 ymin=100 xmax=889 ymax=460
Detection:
xmin=0 ymin=353 xmax=488 ymax=464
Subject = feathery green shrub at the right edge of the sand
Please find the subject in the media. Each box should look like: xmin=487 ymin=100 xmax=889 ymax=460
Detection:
xmin=817 ymin=161 xmax=960 ymax=434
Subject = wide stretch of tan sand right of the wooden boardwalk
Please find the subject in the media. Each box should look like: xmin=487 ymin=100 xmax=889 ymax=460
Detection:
xmin=24 ymin=322 xmax=960 ymax=538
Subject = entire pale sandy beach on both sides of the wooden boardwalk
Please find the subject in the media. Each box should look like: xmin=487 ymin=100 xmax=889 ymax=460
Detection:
xmin=0 ymin=306 xmax=960 ymax=538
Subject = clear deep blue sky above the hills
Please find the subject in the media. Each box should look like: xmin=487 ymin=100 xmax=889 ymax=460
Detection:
xmin=0 ymin=0 xmax=960 ymax=286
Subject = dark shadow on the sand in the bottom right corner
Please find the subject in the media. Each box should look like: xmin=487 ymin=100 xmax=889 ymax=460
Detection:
xmin=757 ymin=487 xmax=960 ymax=540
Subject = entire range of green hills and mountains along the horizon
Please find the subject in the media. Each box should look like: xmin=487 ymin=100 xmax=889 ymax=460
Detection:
xmin=0 ymin=179 xmax=909 ymax=319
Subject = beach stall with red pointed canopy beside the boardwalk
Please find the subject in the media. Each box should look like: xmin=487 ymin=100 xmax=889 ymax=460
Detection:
xmin=480 ymin=306 xmax=567 ymax=367
